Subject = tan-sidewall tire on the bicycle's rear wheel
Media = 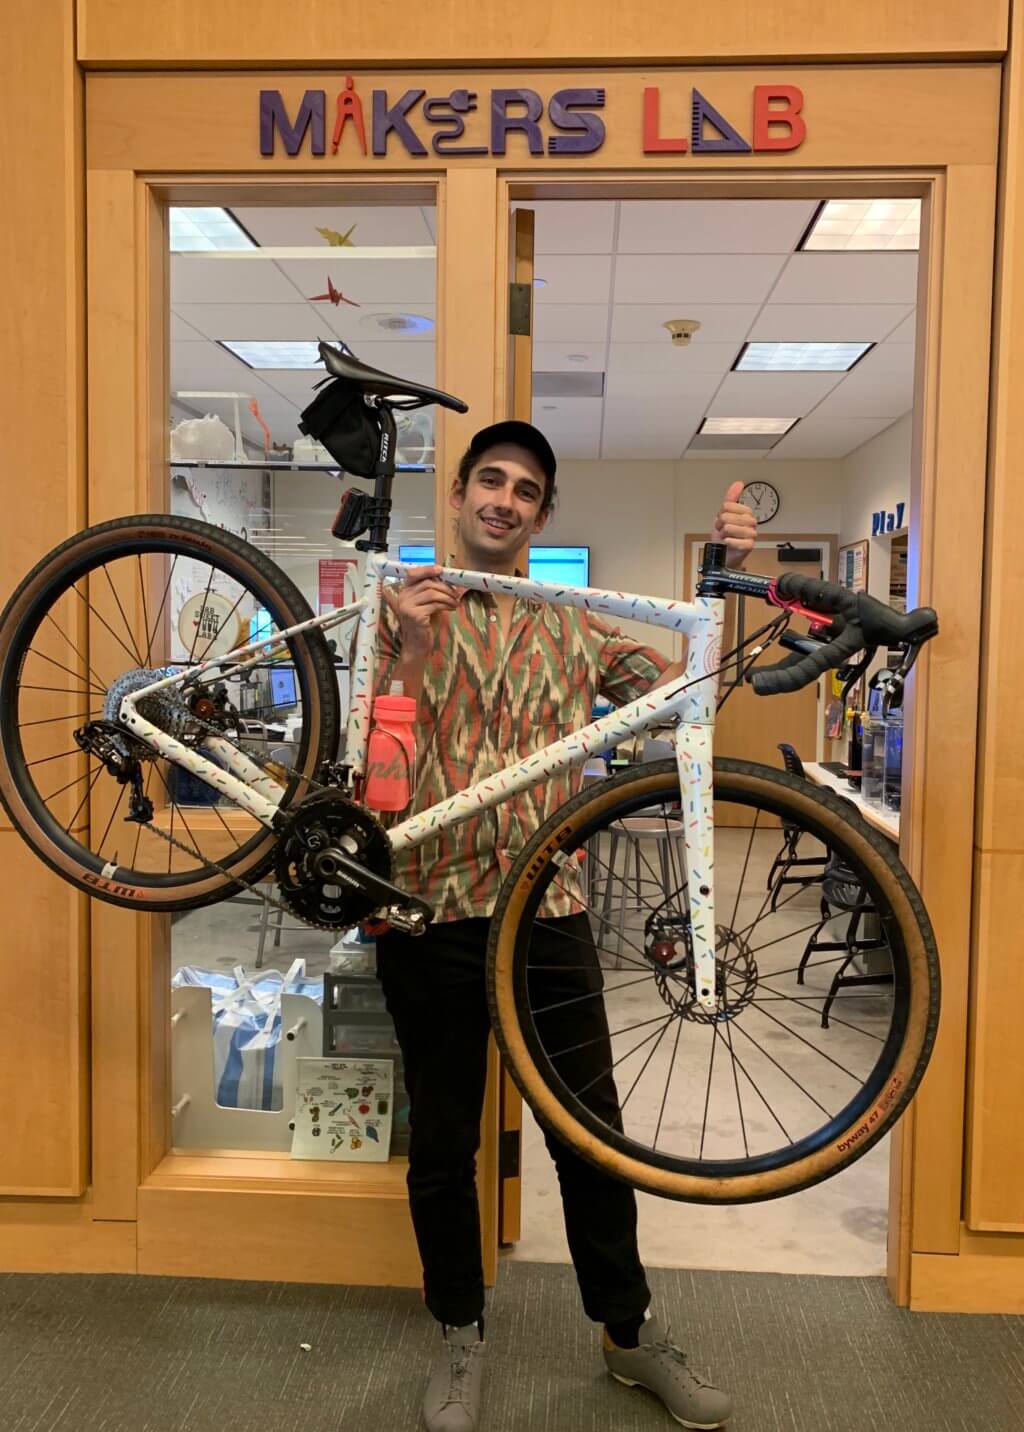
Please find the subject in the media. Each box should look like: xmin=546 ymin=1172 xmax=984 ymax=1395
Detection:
xmin=0 ymin=514 xmax=337 ymax=911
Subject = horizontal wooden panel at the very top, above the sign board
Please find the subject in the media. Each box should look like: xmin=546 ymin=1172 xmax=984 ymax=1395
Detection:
xmin=79 ymin=0 xmax=1008 ymax=69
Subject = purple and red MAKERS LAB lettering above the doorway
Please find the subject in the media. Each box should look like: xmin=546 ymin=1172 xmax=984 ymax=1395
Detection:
xmin=259 ymin=74 xmax=806 ymax=159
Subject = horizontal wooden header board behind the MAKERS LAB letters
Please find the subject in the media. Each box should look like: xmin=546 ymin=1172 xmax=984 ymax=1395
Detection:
xmin=86 ymin=66 xmax=1000 ymax=174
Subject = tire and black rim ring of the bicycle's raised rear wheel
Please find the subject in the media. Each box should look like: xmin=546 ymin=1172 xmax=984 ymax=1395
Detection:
xmin=0 ymin=514 xmax=338 ymax=912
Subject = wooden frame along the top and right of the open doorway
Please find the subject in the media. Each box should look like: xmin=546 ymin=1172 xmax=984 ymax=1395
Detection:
xmin=498 ymin=164 xmax=995 ymax=1306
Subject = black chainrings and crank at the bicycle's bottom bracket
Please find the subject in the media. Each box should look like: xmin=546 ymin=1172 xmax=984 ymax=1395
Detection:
xmin=275 ymin=790 xmax=391 ymax=929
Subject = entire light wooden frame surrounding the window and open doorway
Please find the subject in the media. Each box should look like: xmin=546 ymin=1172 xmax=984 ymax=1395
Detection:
xmin=86 ymin=55 xmax=998 ymax=1302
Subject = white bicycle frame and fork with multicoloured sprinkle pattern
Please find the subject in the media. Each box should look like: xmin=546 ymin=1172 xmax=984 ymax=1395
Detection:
xmin=120 ymin=553 xmax=725 ymax=1010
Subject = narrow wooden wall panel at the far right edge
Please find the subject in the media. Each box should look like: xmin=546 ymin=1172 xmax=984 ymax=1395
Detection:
xmin=965 ymin=6 xmax=1024 ymax=1231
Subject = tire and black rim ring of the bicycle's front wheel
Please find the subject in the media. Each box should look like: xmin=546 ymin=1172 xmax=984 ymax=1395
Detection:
xmin=487 ymin=759 xmax=940 ymax=1203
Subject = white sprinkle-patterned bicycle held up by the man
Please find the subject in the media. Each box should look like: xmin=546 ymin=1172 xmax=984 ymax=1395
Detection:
xmin=0 ymin=344 xmax=940 ymax=1203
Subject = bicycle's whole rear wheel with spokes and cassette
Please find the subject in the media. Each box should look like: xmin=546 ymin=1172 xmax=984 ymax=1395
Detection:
xmin=0 ymin=516 xmax=338 ymax=911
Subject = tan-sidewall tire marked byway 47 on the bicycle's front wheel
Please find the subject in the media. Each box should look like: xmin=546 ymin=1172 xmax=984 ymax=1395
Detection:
xmin=487 ymin=760 xmax=940 ymax=1203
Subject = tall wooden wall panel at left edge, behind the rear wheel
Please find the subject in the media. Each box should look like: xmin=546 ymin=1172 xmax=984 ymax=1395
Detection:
xmin=0 ymin=0 xmax=89 ymax=1196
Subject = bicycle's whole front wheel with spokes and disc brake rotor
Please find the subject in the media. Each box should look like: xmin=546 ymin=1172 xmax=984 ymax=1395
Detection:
xmin=488 ymin=760 xmax=940 ymax=1203
